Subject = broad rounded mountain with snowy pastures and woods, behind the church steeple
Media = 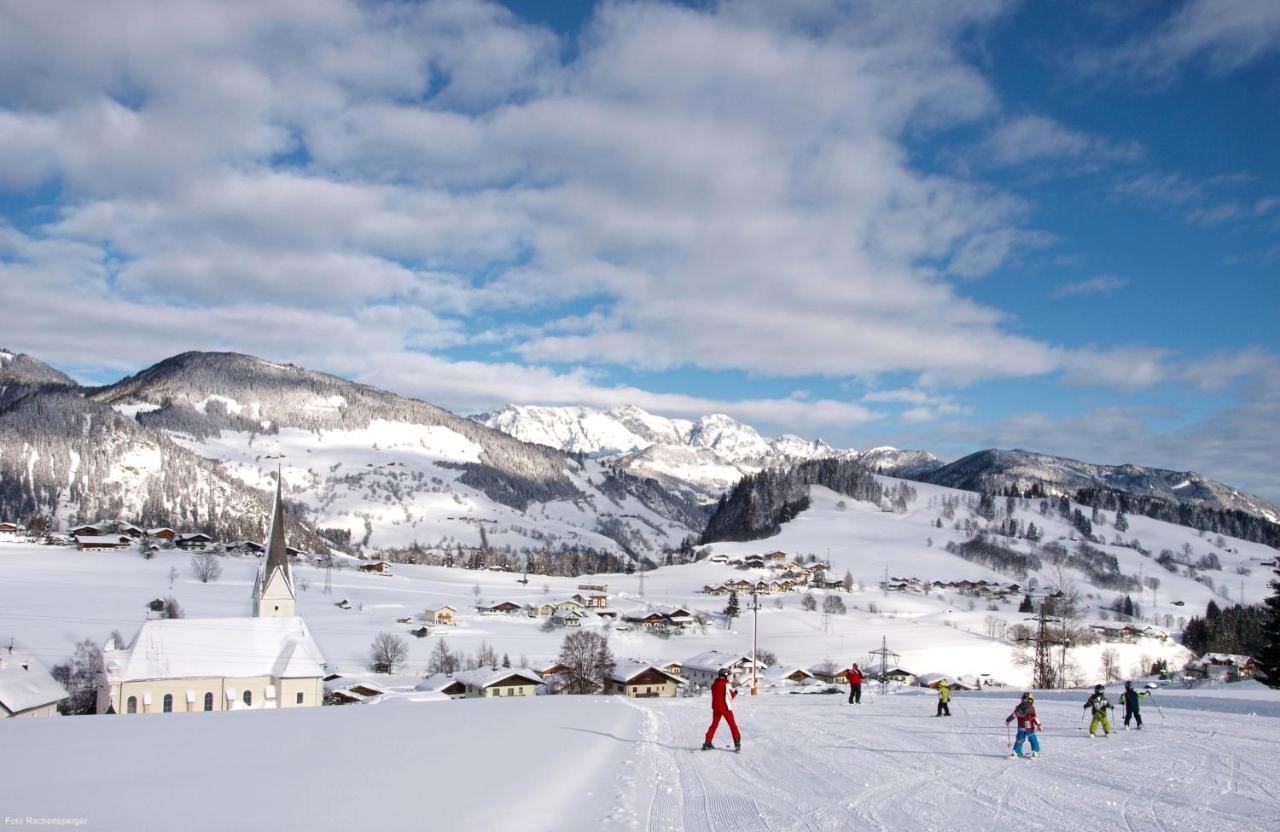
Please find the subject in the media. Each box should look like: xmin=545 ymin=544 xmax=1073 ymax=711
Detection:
xmin=73 ymin=352 xmax=704 ymax=557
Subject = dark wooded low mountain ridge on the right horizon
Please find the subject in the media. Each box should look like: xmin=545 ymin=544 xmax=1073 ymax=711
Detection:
xmin=918 ymin=449 xmax=1280 ymax=522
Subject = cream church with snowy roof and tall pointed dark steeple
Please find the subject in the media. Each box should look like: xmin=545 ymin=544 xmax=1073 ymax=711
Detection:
xmin=97 ymin=481 xmax=325 ymax=714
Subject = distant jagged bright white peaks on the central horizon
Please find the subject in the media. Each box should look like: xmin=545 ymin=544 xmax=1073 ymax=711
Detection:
xmin=476 ymin=404 xmax=942 ymax=502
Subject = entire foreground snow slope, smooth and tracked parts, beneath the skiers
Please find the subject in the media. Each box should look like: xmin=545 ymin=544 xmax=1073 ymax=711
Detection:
xmin=0 ymin=686 xmax=1280 ymax=832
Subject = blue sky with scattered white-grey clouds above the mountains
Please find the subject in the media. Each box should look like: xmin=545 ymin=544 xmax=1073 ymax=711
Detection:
xmin=0 ymin=0 xmax=1280 ymax=500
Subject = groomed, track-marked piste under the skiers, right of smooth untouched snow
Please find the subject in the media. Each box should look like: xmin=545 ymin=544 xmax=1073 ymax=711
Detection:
xmin=605 ymin=696 xmax=1280 ymax=832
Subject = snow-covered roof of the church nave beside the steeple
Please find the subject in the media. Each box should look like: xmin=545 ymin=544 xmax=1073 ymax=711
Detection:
xmin=104 ymin=617 xmax=324 ymax=684
